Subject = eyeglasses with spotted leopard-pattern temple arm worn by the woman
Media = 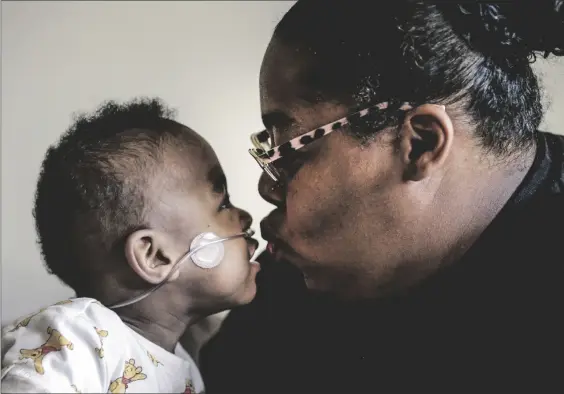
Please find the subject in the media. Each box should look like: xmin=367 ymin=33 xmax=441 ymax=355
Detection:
xmin=249 ymin=102 xmax=413 ymax=182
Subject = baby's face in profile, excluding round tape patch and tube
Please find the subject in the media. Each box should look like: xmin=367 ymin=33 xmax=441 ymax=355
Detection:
xmin=147 ymin=131 xmax=260 ymax=313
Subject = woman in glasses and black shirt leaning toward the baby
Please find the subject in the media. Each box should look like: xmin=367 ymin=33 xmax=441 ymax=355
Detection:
xmin=202 ymin=0 xmax=564 ymax=394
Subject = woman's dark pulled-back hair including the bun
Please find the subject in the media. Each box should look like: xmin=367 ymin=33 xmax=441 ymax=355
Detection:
xmin=274 ymin=0 xmax=564 ymax=154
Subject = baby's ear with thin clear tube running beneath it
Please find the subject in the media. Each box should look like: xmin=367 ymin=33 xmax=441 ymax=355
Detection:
xmin=125 ymin=230 xmax=179 ymax=285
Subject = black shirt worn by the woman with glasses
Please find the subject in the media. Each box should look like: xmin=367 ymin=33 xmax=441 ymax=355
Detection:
xmin=201 ymin=132 xmax=564 ymax=394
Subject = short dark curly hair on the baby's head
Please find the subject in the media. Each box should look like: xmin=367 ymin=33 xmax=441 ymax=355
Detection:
xmin=33 ymin=98 xmax=189 ymax=290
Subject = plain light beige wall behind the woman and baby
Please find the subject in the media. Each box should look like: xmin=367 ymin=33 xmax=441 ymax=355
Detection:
xmin=1 ymin=1 xmax=564 ymax=324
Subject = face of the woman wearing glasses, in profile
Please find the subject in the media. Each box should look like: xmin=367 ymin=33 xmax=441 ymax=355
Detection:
xmin=259 ymin=40 xmax=424 ymax=297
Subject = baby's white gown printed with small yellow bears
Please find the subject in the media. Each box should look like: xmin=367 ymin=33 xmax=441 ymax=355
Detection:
xmin=1 ymin=298 xmax=204 ymax=394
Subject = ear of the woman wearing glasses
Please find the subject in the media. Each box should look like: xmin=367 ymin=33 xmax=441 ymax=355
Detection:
xmin=400 ymin=104 xmax=454 ymax=181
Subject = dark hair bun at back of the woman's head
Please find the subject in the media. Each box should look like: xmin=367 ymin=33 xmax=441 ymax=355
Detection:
xmin=439 ymin=0 xmax=564 ymax=62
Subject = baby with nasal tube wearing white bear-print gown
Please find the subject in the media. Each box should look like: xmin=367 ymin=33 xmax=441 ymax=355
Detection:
xmin=2 ymin=99 xmax=260 ymax=393
